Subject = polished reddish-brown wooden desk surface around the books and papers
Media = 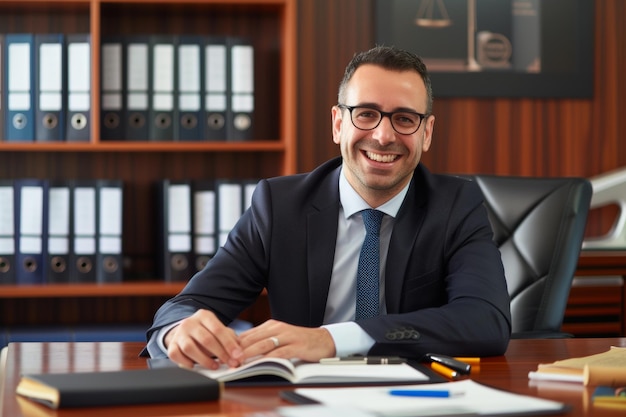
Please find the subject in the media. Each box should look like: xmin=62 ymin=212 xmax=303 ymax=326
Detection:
xmin=0 ymin=338 xmax=626 ymax=417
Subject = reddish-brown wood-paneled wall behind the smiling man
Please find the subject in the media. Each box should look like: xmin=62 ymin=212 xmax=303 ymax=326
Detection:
xmin=298 ymin=0 xmax=626 ymax=234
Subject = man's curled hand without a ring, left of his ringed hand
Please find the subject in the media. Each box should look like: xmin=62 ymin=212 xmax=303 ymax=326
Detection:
xmin=164 ymin=310 xmax=244 ymax=369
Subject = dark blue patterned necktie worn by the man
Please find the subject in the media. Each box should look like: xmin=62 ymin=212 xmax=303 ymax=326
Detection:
xmin=356 ymin=209 xmax=383 ymax=320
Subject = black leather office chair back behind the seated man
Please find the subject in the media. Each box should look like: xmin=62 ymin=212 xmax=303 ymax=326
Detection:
xmin=465 ymin=175 xmax=592 ymax=338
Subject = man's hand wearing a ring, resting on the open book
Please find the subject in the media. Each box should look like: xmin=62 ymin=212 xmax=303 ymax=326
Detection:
xmin=239 ymin=320 xmax=335 ymax=362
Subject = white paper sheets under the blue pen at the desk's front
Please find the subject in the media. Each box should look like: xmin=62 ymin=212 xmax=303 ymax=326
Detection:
xmin=279 ymin=379 xmax=568 ymax=417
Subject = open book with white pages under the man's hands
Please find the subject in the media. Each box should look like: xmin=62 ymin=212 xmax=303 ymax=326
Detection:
xmin=195 ymin=358 xmax=430 ymax=385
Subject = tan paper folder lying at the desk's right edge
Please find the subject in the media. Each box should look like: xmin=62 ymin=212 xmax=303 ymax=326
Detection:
xmin=528 ymin=346 xmax=626 ymax=386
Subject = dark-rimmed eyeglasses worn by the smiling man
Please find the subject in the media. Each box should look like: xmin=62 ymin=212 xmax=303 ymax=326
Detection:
xmin=337 ymin=104 xmax=428 ymax=135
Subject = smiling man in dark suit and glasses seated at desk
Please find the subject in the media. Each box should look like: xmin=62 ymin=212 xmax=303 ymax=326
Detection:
xmin=147 ymin=47 xmax=511 ymax=368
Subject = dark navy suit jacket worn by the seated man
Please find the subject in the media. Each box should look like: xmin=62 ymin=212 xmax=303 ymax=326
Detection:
xmin=148 ymin=158 xmax=511 ymax=357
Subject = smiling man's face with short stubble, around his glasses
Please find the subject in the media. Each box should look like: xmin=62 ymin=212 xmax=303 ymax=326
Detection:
xmin=332 ymin=64 xmax=435 ymax=207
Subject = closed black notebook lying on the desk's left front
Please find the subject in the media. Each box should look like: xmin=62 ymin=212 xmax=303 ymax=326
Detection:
xmin=16 ymin=367 xmax=221 ymax=409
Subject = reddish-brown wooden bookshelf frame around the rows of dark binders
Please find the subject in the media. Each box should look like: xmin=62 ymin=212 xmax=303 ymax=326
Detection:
xmin=0 ymin=0 xmax=297 ymax=332
